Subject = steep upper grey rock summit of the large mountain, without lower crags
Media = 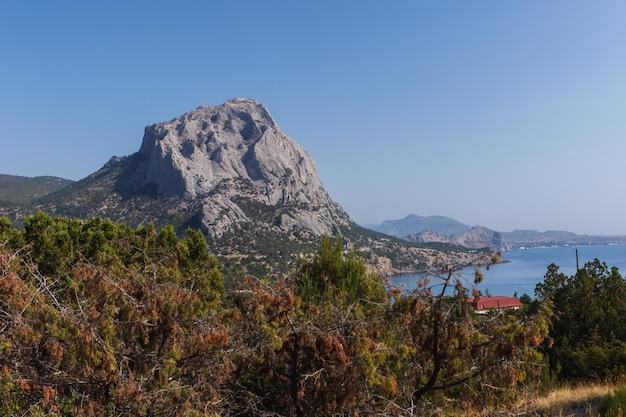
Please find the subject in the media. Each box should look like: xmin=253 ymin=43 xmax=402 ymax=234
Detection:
xmin=139 ymin=98 xmax=322 ymax=204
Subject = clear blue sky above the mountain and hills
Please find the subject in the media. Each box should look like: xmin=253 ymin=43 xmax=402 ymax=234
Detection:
xmin=0 ymin=0 xmax=626 ymax=234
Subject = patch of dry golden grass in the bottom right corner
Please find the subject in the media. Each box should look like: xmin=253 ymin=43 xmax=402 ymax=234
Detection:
xmin=533 ymin=383 xmax=616 ymax=417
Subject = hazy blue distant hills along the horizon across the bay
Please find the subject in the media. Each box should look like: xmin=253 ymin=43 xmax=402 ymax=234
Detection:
xmin=366 ymin=214 xmax=626 ymax=250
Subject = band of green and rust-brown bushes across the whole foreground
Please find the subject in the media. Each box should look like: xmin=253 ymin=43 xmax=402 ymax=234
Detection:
xmin=0 ymin=213 xmax=625 ymax=416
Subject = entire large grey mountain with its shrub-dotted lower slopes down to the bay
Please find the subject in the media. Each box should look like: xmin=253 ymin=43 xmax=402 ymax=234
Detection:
xmin=0 ymin=98 xmax=488 ymax=274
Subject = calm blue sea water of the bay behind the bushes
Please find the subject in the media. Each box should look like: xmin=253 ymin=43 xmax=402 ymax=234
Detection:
xmin=391 ymin=245 xmax=626 ymax=297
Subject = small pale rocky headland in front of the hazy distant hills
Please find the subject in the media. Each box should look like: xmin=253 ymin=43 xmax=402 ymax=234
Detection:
xmin=405 ymin=226 xmax=507 ymax=251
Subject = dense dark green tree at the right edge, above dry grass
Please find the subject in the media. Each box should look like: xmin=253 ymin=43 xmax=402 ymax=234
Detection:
xmin=535 ymin=259 xmax=626 ymax=380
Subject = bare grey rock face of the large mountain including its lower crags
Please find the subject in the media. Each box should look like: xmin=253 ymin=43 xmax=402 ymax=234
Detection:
xmin=139 ymin=98 xmax=349 ymax=236
